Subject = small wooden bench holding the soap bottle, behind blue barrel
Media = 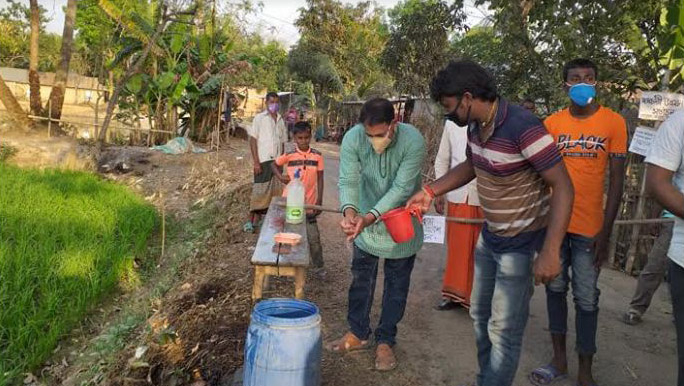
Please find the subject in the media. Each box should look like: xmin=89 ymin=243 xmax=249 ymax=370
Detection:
xmin=251 ymin=197 xmax=310 ymax=301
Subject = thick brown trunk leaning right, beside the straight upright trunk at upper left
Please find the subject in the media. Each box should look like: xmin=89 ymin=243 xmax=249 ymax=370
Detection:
xmin=49 ymin=0 xmax=77 ymax=119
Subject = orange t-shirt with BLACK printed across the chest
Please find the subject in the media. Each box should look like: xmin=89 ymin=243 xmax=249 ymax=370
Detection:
xmin=544 ymin=106 xmax=627 ymax=237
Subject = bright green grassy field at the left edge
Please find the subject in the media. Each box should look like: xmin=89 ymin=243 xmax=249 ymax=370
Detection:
xmin=0 ymin=163 xmax=158 ymax=385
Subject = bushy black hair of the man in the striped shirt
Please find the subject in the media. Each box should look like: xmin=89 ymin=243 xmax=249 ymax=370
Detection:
xmin=430 ymin=59 xmax=497 ymax=102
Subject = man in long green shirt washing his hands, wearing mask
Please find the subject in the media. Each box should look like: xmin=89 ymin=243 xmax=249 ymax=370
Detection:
xmin=328 ymin=98 xmax=425 ymax=371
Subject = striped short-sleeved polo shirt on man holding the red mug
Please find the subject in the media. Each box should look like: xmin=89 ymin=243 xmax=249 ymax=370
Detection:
xmin=466 ymin=98 xmax=561 ymax=244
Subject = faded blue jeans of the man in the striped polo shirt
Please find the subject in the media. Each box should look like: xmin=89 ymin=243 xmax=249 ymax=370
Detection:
xmin=470 ymin=236 xmax=536 ymax=386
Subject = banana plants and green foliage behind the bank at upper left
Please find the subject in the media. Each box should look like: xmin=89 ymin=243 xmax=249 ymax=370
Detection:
xmin=99 ymin=0 xmax=287 ymax=140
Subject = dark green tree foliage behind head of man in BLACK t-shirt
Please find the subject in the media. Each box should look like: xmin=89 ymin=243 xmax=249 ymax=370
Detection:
xmin=478 ymin=0 xmax=681 ymax=112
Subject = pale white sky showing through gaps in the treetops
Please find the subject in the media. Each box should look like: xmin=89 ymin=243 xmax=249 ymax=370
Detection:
xmin=9 ymin=0 xmax=489 ymax=48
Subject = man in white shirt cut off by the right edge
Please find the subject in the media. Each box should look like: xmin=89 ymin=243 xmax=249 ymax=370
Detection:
xmin=646 ymin=110 xmax=684 ymax=386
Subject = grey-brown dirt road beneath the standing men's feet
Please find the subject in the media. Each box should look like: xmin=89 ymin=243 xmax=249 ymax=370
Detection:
xmin=306 ymin=153 xmax=676 ymax=386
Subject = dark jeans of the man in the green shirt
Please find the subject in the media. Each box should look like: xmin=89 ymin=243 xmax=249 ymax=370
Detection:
xmin=347 ymin=245 xmax=416 ymax=346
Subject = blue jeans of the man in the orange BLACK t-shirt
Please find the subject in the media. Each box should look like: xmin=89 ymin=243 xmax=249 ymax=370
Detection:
xmin=546 ymin=233 xmax=600 ymax=355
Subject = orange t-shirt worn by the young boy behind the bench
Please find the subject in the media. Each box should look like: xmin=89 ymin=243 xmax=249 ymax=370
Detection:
xmin=275 ymin=146 xmax=323 ymax=205
